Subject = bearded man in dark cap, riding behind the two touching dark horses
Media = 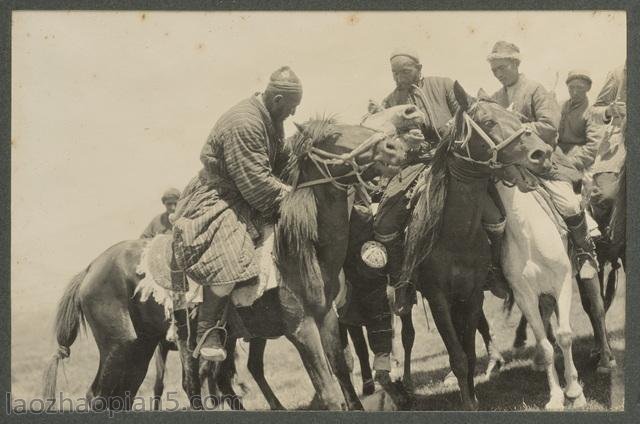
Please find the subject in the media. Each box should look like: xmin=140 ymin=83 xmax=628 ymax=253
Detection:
xmin=363 ymin=50 xmax=507 ymax=313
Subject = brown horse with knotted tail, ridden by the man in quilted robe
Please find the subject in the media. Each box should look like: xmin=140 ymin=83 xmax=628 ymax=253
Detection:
xmin=44 ymin=107 xmax=424 ymax=409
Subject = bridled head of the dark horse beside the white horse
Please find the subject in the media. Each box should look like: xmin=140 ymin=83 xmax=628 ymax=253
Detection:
xmin=453 ymin=81 xmax=553 ymax=179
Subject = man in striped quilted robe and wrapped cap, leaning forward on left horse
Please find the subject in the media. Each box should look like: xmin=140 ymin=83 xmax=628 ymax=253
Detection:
xmin=172 ymin=66 xmax=302 ymax=361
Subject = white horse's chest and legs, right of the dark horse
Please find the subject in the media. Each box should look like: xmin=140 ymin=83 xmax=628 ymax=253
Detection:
xmin=496 ymin=183 xmax=586 ymax=410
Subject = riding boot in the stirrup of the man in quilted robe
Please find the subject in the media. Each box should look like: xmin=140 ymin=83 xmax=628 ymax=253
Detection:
xmin=193 ymin=287 xmax=229 ymax=362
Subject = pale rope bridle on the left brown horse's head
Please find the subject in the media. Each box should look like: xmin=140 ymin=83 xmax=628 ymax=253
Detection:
xmin=293 ymin=127 xmax=395 ymax=191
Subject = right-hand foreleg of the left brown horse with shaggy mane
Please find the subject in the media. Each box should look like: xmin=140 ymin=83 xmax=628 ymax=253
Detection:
xmin=319 ymin=308 xmax=363 ymax=410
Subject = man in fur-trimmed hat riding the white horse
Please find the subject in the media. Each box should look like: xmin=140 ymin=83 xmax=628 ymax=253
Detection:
xmin=483 ymin=41 xmax=598 ymax=278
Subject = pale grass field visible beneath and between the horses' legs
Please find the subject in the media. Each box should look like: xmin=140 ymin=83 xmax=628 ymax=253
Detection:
xmin=11 ymin=266 xmax=625 ymax=411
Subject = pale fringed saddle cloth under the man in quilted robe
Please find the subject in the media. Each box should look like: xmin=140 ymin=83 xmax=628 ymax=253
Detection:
xmin=134 ymin=225 xmax=281 ymax=319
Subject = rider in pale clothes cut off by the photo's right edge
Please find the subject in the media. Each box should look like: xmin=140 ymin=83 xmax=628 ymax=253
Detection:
xmin=590 ymin=63 xmax=627 ymax=225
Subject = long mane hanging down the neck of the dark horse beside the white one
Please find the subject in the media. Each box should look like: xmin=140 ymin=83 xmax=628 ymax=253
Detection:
xmin=401 ymin=109 xmax=463 ymax=281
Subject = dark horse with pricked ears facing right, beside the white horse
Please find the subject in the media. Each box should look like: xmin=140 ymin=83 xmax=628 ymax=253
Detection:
xmin=402 ymin=82 xmax=551 ymax=410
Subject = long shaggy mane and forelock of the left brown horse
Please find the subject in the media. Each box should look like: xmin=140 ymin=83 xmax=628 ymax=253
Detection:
xmin=275 ymin=117 xmax=336 ymax=307
